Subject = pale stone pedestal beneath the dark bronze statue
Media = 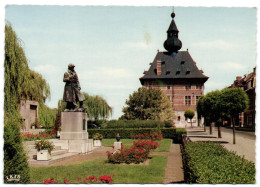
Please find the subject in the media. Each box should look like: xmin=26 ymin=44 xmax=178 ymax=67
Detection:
xmin=60 ymin=112 xmax=90 ymax=153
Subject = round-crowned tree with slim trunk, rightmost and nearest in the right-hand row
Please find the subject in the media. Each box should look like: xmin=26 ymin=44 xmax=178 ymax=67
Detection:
xmin=222 ymin=88 xmax=249 ymax=144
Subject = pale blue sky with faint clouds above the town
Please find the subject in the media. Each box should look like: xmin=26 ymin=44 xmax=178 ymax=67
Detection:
xmin=5 ymin=5 xmax=257 ymax=119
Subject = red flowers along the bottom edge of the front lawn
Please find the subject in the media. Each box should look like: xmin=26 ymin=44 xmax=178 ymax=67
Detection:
xmin=43 ymin=175 xmax=114 ymax=184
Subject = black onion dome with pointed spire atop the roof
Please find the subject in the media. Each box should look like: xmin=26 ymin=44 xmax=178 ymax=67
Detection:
xmin=164 ymin=12 xmax=182 ymax=54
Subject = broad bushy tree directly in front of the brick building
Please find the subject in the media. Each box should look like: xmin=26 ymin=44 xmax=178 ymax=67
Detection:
xmin=120 ymin=87 xmax=175 ymax=121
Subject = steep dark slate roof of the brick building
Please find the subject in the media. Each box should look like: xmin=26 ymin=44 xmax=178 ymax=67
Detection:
xmin=140 ymin=51 xmax=209 ymax=84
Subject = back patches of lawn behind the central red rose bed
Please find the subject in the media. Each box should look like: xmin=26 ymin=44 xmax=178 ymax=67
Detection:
xmin=102 ymin=139 xmax=172 ymax=152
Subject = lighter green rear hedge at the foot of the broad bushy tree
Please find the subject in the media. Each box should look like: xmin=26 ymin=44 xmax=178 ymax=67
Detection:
xmin=102 ymin=120 xmax=173 ymax=129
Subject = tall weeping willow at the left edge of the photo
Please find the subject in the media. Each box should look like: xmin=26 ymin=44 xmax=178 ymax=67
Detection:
xmin=4 ymin=25 xmax=50 ymax=113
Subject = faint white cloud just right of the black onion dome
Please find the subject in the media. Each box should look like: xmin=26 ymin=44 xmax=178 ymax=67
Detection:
xmin=195 ymin=40 xmax=236 ymax=50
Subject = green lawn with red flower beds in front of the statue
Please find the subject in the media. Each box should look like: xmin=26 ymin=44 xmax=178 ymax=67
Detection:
xmin=30 ymin=133 xmax=172 ymax=184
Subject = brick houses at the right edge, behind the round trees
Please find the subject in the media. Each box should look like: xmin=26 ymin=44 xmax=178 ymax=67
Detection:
xmin=230 ymin=68 xmax=256 ymax=129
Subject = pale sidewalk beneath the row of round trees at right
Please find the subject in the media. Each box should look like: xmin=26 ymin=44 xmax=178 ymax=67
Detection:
xmin=186 ymin=127 xmax=255 ymax=163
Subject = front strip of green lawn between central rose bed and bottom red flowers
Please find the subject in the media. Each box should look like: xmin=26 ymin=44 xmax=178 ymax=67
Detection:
xmin=30 ymin=155 xmax=168 ymax=184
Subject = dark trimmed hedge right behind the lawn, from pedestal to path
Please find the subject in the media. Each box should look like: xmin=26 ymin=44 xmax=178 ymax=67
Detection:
xmin=88 ymin=128 xmax=186 ymax=143
